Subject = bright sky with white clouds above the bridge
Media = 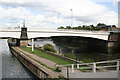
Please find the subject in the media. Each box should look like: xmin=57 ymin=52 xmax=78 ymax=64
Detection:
xmin=0 ymin=0 xmax=118 ymax=28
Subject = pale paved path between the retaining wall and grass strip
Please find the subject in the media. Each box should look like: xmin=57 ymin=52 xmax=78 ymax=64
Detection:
xmin=15 ymin=47 xmax=56 ymax=68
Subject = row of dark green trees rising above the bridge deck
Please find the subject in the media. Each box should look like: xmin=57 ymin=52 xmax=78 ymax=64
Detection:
xmin=58 ymin=23 xmax=116 ymax=31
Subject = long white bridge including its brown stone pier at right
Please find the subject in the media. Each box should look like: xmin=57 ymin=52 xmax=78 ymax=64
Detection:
xmin=0 ymin=28 xmax=120 ymax=53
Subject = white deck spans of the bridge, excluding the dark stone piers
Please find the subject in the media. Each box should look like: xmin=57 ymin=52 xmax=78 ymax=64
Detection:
xmin=0 ymin=29 xmax=110 ymax=41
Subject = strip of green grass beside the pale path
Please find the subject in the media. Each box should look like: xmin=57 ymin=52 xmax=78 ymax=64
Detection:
xmin=20 ymin=47 xmax=73 ymax=64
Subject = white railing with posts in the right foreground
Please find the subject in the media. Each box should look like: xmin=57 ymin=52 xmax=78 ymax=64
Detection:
xmin=56 ymin=59 xmax=120 ymax=73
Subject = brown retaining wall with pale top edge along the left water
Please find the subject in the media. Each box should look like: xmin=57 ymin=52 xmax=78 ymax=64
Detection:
xmin=10 ymin=47 xmax=58 ymax=79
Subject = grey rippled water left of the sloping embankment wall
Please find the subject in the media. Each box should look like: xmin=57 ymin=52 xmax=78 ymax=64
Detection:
xmin=0 ymin=39 xmax=35 ymax=78
